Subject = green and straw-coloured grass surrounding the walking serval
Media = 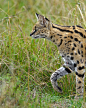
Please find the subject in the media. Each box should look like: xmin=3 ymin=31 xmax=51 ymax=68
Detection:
xmin=0 ymin=0 xmax=86 ymax=108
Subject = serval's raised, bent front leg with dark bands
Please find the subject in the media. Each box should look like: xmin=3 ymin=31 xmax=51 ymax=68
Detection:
xmin=50 ymin=62 xmax=75 ymax=93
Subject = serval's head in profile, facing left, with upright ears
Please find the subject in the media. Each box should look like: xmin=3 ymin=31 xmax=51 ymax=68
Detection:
xmin=30 ymin=13 xmax=52 ymax=39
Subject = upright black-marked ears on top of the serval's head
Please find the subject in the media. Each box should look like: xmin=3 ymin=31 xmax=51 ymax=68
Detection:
xmin=36 ymin=13 xmax=52 ymax=29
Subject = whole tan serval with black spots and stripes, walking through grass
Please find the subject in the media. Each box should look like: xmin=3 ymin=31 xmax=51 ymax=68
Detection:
xmin=30 ymin=13 xmax=86 ymax=97
